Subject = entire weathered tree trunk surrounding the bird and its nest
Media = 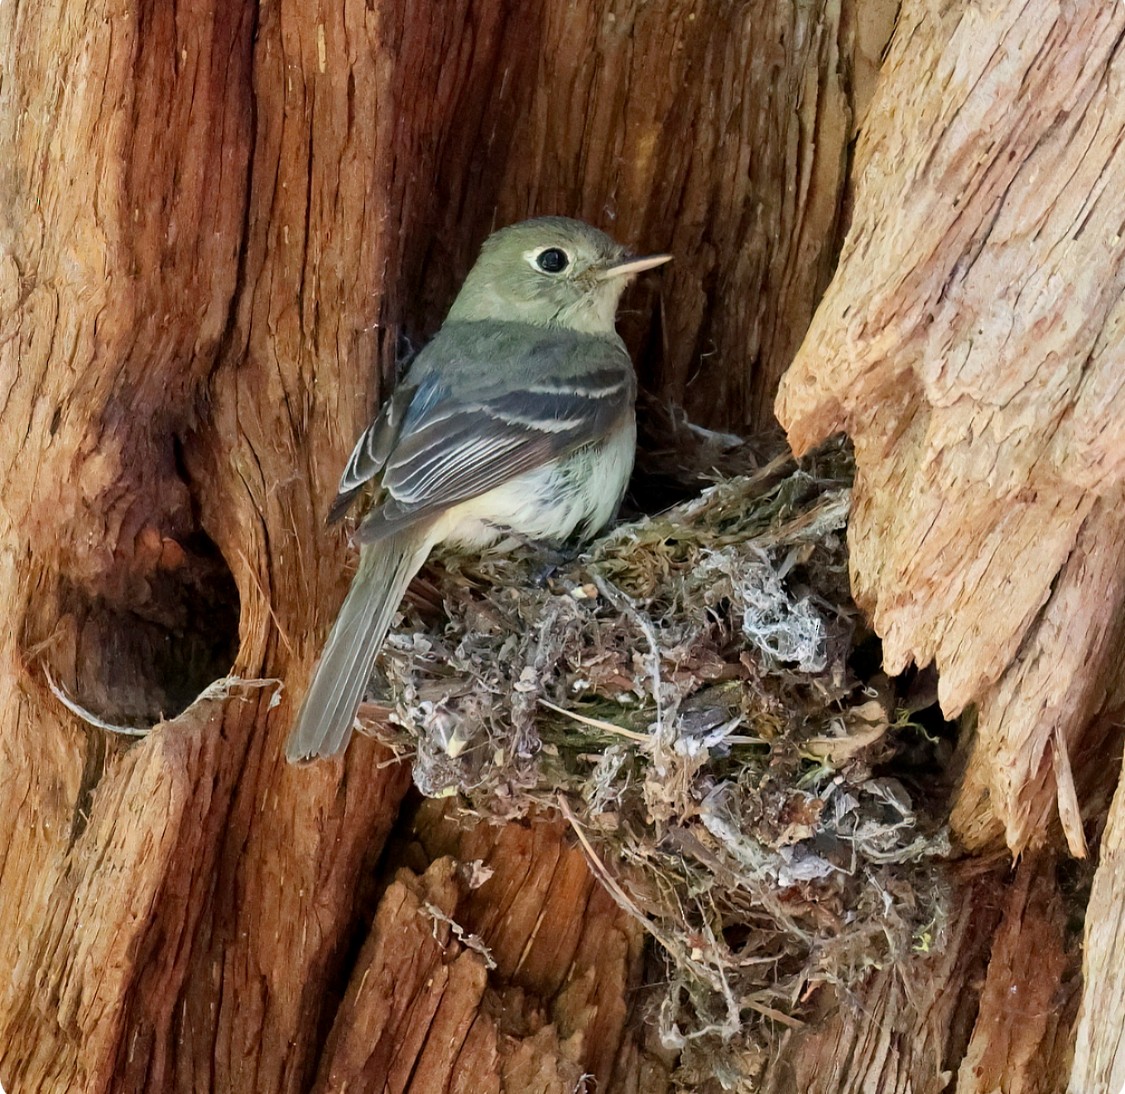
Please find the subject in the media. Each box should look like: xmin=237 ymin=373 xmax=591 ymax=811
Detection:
xmin=0 ymin=0 xmax=1125 ymax=1094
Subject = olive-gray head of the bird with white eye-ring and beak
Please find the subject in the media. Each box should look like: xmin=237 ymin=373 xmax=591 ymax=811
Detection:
xmin=449 ymin=216 xmax=672 ymax=334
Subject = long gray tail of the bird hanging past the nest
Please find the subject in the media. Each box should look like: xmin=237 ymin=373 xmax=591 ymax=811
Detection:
xmin=285 ymin=528 xmax=431 ymax=763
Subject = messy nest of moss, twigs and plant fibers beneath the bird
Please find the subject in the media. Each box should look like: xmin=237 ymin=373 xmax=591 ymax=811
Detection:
xmin=369 ymin=445 xmax=948 ymax=1088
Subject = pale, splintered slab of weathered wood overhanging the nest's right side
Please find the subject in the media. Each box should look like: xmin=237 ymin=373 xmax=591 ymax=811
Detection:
xmin=777 ymin=0 xmax=1125 ymax=853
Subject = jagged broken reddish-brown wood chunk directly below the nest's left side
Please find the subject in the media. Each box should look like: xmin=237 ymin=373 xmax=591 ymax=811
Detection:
xmin=315 ymin=807 xmax=668 ymax=1094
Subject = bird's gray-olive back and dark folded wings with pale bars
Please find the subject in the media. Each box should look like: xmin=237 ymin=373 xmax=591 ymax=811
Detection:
xmin=330 ymin=324 xmax=636 ymax=542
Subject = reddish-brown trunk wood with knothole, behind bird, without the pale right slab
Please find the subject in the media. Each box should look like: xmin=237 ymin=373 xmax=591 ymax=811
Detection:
xmin=0 ymin=0 xmax=894 ymax=1094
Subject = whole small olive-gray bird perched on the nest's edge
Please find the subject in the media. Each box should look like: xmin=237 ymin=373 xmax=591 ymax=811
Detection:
xmin=286 ymin=216 xmax=672 ymax=762
